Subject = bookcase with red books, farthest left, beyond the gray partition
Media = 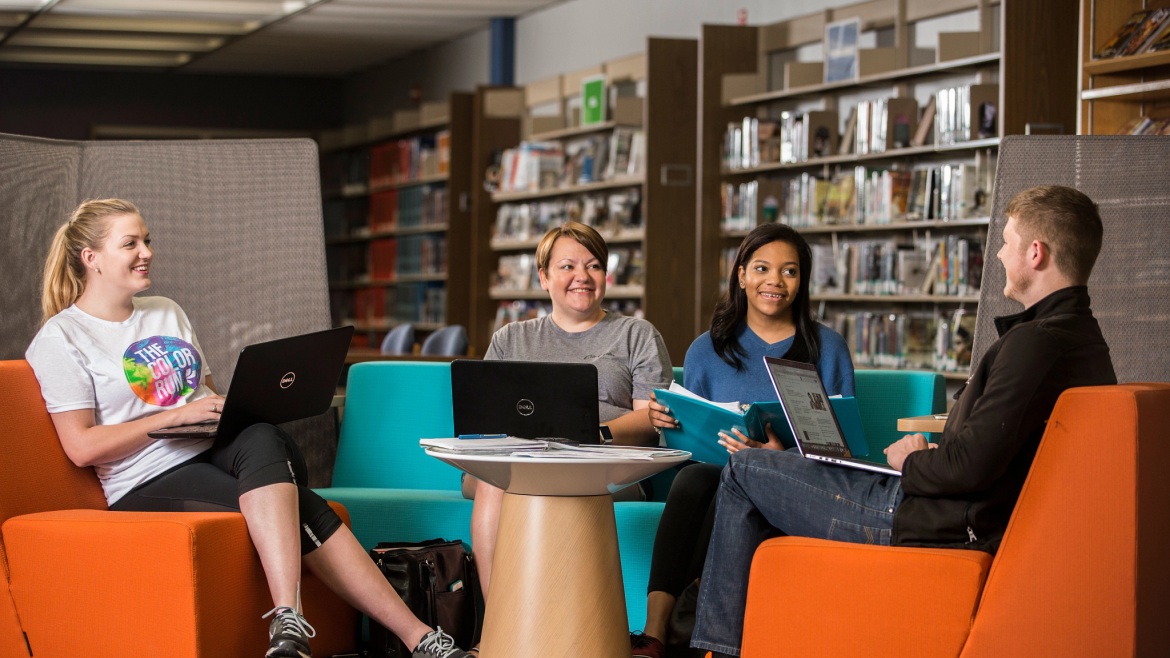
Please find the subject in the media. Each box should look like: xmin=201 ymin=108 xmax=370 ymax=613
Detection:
xmin=318 ymin=92 xmax=474 ymax=350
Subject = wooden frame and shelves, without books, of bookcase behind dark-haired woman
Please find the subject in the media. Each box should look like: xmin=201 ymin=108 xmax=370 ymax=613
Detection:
xmin=693 ymin=0 xmax=1076 ymax=378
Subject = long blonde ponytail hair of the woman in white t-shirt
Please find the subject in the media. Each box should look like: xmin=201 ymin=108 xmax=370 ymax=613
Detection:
xmin=41 ymin=199 xmax=142 ymax=323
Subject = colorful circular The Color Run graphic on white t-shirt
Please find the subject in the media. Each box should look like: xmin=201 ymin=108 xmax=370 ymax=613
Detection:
xmin=122 ymin=336 xmax=204 ymax=406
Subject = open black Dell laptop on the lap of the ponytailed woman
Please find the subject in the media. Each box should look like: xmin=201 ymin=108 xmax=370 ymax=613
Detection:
xmin=146 ymin=327 xmax=353 ymax=440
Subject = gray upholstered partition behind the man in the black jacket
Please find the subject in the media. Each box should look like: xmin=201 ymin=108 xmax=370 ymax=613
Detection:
xmin=972 ymin=136 xmax=1170 ymax=382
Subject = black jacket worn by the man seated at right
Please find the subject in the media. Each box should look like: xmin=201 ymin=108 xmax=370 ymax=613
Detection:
xmin=893 ymin=286 xmax=1117 ymax=554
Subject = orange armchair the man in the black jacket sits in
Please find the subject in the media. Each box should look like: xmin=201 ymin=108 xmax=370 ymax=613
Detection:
xmin=742 ymin=384 xmax=1170 ymax=658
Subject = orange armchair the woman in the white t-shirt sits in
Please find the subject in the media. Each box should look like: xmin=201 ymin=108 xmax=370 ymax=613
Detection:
xmin=0 ymin=361 xmax=357 ymax=658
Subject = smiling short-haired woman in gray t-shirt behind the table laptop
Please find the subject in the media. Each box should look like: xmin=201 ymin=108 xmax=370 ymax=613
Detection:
xmin=472 ymin=221 xmax=674 ymax=597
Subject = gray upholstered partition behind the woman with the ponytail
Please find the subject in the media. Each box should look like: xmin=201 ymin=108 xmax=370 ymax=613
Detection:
xmin=0 ymin=130 xmax=336 ymax=486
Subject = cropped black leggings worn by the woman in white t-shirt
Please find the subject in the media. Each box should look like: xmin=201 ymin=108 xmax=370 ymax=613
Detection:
xmin=110 ymin=423 xmax=342 ymax=555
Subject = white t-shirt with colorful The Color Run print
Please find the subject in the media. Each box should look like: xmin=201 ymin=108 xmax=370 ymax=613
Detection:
xmin=25 ymin=297 xmax=214 ymax=505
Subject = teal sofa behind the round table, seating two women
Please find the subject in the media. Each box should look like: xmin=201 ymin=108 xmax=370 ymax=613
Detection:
xmin=316 ymin=362 xmax=945 ymax=630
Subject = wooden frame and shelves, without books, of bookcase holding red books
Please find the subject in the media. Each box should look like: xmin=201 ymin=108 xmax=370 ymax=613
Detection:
xmin=322 ymin=92 xmax=474 ymax=348
